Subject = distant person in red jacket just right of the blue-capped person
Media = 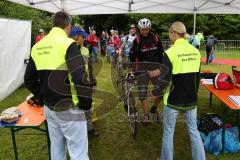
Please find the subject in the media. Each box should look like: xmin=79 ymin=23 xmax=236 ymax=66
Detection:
xmin=88 ymin=30 xmax=99 ymax=62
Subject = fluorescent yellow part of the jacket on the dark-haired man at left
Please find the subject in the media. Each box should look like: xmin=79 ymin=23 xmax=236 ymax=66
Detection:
xmin=31 ymin=27 xmax=78 ymax=105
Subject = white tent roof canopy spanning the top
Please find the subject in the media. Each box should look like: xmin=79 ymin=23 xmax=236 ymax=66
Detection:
xmin=6 ymin=0 xmax=240 ymax=15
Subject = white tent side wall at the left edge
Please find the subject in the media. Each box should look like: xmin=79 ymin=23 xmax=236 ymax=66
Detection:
xmin=0 ymin=18 xmax=32 ymax=100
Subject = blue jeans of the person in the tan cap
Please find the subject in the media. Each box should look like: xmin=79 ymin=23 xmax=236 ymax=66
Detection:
xmin=161 ymin=106 xmax=206 ymax=160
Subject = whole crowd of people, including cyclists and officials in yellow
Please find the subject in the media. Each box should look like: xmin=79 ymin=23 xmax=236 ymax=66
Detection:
xmin=24 ymin=11 xmax=222 ymax=160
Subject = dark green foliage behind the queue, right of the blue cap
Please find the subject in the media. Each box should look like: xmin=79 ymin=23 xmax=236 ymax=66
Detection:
xmin=80 ymin=14 xmax=240 ymax=39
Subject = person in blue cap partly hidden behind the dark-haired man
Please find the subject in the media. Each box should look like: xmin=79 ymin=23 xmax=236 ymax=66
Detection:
xmin=69 ymin=27 xmax=99 ymax=137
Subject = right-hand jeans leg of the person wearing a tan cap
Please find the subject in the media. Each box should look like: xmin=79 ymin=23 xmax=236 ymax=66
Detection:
xmin=185 ymin=108 xmax=206 ymax=160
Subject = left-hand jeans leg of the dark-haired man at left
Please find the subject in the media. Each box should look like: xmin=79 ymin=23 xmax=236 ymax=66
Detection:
xmin=44 ymin=106 xmax=66 ymax=160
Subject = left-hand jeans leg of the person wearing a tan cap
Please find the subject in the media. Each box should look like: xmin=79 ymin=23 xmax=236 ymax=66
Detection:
xmin=160 ymin=106 xmax=179 ymax=160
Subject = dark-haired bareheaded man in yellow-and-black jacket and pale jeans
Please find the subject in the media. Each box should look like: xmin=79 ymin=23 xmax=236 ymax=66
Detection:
xmin=24 ymin=11 xmax=89 ymax=160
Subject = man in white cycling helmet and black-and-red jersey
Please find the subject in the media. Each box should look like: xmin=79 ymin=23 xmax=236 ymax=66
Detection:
xmin=129 ymin=18 xmax=164 ymax=124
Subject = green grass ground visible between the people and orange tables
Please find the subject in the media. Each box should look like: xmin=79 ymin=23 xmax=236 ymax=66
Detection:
xmin=0 ymin=55 xmax=240 ymax=160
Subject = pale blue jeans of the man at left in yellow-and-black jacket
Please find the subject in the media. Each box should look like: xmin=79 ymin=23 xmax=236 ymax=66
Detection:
xmin=44 ymin=106 xmax=89 ymax=160
